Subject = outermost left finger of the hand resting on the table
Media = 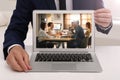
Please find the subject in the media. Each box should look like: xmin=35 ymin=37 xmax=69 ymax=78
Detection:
xmin=6 ymin=55 xmax=23 ymax=72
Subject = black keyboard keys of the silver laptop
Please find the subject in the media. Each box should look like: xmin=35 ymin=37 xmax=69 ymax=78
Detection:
xmin=35 ymin=53 xmax=93 ymax=62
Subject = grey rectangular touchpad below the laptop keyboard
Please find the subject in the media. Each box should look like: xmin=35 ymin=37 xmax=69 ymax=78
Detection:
xmin=52 ymin=63 xmax=76 ymax=70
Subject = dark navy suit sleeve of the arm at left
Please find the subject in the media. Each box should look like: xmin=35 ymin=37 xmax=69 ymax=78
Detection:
xmin=3 ymin=0 xmax=33 ymax=59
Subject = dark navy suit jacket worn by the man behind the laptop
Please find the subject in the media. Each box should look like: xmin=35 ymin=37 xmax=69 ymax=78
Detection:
xmin=3 ymin=0 xmax=110 ymax=58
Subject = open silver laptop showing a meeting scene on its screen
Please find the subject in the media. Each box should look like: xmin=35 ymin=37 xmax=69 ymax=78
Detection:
xmin=30 ymin=10 xmax=102 ymax=73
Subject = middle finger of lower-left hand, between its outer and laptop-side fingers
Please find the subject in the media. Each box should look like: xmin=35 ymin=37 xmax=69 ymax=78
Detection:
xmin=15 ymin=53 xmax=28 ymax=72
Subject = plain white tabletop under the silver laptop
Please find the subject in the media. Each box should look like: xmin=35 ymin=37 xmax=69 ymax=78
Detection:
xmin=0 ymin=46 xmax=120 ymax=80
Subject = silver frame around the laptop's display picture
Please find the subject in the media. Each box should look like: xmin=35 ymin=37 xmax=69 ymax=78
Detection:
xmin=33 ymin=10 xmax=95 ymax=52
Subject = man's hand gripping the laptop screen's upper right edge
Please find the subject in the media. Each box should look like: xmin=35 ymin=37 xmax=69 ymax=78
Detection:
xmin=94 ymin=8 xmax=112 ymax=27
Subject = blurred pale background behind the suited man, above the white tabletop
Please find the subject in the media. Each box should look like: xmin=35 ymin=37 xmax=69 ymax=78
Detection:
xmin=0 ymin=0 xmax=120 ymax=46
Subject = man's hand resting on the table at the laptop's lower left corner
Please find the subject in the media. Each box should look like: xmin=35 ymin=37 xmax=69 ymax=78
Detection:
xmin=6 ymin=46 xmax=31 ymax=72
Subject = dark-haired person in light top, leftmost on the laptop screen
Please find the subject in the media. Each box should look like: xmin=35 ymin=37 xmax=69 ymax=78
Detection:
xmin=37 ymin=22 xmax=54 ymax=48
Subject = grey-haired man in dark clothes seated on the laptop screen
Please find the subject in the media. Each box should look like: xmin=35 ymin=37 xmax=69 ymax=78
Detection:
xmin=67 ymin=21 xmax=85 ymax=48
